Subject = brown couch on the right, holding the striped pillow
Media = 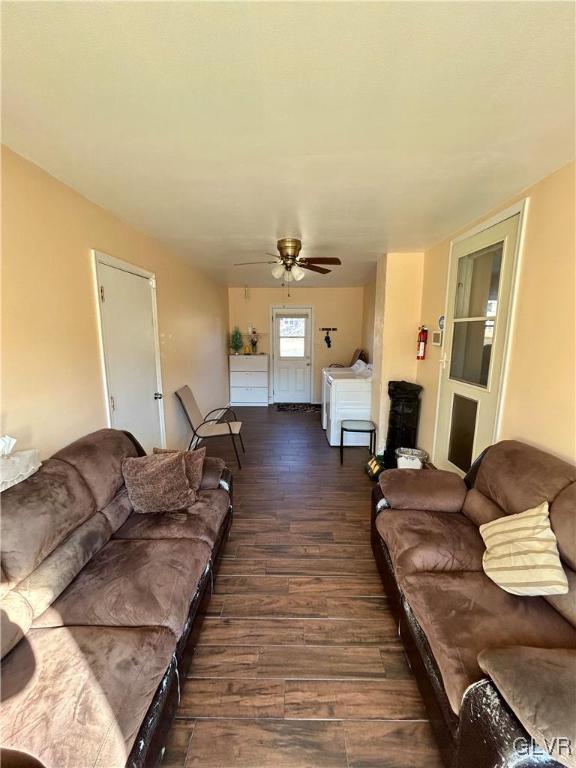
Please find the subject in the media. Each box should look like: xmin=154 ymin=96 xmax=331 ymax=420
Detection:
xmin=372 ymin=441 xmax=576 ymax=768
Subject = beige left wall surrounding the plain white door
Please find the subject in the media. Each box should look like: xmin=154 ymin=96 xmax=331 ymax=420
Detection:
xmin=1 ymin=148 xmax=228 ymax=456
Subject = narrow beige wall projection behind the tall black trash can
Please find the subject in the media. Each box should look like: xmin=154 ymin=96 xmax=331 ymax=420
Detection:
xmin=372 ymin=253 xmax=424 ymax=452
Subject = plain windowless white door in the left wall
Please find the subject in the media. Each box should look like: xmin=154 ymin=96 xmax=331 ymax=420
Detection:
xmin=97 ymin=257 xmax=165 ymax=452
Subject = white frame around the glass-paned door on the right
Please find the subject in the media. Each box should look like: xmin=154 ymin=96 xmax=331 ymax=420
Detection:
xmin=432 ymin=197 xmax=530 ymax=476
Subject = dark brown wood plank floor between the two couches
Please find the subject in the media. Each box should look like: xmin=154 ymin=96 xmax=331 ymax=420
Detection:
xmin=162 ymin=407 xmax=441 ymax=768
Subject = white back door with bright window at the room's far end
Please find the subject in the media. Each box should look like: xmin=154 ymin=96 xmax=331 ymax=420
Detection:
xmin=272 ymin=309 xmax=312 ymax=403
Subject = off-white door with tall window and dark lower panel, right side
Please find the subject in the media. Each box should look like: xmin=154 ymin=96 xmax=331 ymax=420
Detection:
xmin=434 ymin=214 xmax=520 ymax=473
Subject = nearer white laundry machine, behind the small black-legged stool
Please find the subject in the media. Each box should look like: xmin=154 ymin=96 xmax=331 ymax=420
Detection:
xmin=326 ymin=369 xmax=372 ymax=446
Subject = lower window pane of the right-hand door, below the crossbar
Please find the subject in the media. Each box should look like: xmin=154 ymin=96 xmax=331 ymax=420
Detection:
xmin=450 ymin=320 xmax=494 ymax=387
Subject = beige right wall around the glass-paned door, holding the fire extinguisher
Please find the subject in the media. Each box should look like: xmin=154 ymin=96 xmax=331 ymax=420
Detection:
xmin=417 ymin=163 xmax=576 ymax=460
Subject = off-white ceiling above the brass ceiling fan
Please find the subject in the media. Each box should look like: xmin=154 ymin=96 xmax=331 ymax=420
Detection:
xmin=2 ymin=1 xmax=574 ymax=286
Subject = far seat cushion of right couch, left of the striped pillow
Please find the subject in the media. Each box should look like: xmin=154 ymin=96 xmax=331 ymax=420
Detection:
xmin=376 ymin=509 xmax=484 ymax=578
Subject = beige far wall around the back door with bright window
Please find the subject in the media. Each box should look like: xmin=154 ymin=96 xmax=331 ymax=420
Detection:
xmin=228 ymin=286 xmax=364 ymax=402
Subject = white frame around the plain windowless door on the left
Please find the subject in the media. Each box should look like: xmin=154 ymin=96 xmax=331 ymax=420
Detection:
xmin=91 ymin=248 xmax=166 ymax=448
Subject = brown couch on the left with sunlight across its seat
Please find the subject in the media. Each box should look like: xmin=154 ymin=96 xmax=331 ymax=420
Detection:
xmin=0 ymin=429 xmax=232 ymax=768
